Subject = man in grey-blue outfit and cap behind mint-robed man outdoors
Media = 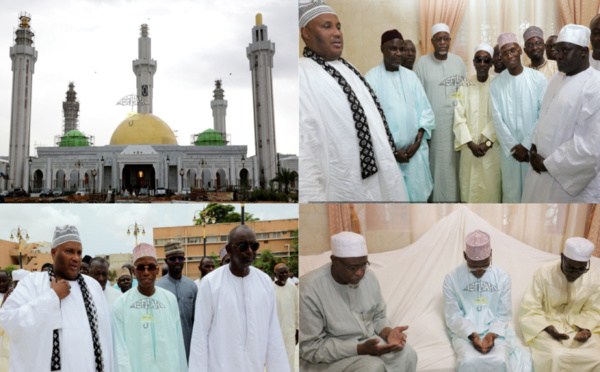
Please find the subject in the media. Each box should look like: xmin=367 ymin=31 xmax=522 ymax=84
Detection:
xmin=156 ymin=242 xmax=198 ymax=360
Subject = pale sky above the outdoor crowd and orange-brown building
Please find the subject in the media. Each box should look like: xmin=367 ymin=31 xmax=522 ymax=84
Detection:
xmin=0 ymin=203 xmax=298 ymax=257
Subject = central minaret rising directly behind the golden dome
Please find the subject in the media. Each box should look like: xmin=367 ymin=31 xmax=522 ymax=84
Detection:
xmin=133 ymin=24 xmax=156 ymax=114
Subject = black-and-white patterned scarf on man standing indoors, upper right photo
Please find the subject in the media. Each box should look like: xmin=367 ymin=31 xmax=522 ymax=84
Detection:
xmin=303 ymin=48 xmax=396 ymax=179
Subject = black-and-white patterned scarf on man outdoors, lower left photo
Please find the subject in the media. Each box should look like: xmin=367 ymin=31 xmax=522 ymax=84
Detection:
xmin=48 ymin=265 xmax=104 ymax=372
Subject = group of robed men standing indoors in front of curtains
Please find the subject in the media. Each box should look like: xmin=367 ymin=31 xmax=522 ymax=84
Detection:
xmin=298 ymin=0 xmax=600 ymax=203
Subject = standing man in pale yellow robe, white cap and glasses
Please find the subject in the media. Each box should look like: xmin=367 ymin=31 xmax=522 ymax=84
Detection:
xmin=454 ymin=44 xmax=502 ymax=203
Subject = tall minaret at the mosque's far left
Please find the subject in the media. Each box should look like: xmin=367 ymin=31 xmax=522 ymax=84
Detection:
xmin=9 ymin=12 xmax=37 ymax=188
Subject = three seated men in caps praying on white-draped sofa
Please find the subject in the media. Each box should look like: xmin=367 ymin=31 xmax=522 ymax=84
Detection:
xmin=300 ymin=230 xmax=600 ymax=372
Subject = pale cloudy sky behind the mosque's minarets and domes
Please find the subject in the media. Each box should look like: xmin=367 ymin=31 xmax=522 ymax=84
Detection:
xmin=0 ymin=0 xmax=298 ymax=156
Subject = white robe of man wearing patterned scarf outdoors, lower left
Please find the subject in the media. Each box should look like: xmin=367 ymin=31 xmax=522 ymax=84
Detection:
xmin=0 ymin=272 xmax=113 ymax=372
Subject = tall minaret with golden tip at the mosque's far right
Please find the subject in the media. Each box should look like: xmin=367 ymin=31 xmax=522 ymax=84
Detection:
xmin=246 ymin=13 xmax=277 ymax=188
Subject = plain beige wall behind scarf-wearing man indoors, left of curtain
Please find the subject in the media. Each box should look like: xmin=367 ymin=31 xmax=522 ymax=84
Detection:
xmin=300 ymin=0 xmax=420 ymax=75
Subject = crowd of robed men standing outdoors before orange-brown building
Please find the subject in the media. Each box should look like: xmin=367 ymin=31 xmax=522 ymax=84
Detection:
xmin=0 ymin=225 xmax=298 ymax=372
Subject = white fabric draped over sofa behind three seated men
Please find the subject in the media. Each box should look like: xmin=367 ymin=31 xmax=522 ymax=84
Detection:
xmin=299 ymin=208 xmax=600 ymax=372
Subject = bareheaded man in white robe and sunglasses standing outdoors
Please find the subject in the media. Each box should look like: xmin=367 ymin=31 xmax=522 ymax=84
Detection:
xmin=190 ymin=225 xmax=290 ymax=372
